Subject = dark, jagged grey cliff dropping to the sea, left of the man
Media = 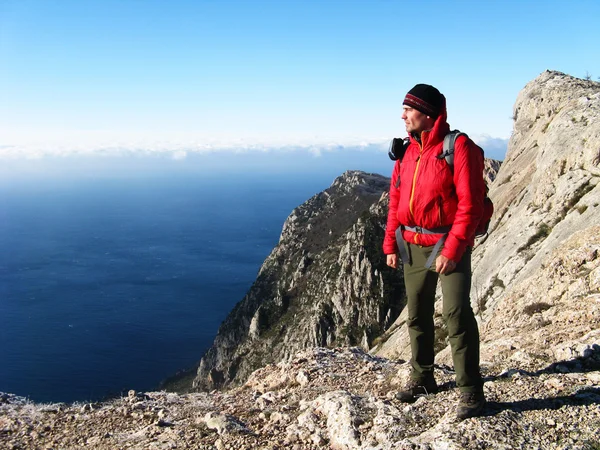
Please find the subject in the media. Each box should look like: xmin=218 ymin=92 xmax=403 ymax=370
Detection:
xmin=193 ymin=172 xmax=403 ymax=390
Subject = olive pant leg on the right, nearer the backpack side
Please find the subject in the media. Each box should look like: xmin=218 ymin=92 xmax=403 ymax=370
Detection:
xmin=440 ymin=248 xmax=483 ymax=392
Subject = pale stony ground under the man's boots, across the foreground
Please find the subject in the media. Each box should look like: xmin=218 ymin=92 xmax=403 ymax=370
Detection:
xmin=0 ymin=348 xmax=600 ymax=450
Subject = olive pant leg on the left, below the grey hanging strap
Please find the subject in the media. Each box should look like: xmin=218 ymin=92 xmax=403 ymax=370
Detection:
xmin=404 ymin=245 xmax=438 ymax=381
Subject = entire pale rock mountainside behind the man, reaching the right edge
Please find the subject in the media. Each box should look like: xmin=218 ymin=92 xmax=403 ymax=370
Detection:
xmin=373 ymin=71 xmax=600 ymax=363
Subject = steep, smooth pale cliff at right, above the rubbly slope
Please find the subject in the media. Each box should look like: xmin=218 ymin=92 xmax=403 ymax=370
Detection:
xmin=474 ymin=71 xmax=600 ymax=310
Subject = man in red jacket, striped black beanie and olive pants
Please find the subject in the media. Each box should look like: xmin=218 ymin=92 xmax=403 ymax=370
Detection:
xmin=383 ymin=84 xmax=486 ymax=420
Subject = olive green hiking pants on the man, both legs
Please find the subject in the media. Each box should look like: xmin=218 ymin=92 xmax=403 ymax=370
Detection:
xmin=404 ymin=245 xmax=483 ymax=392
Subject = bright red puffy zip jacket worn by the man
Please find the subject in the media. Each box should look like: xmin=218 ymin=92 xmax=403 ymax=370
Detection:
xmin=383 ymin=108 xmax=486 ymax=262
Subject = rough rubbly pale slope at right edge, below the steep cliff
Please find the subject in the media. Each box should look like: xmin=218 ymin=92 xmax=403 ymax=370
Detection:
xmin=482 ymin=226 xmax=600 ymax=370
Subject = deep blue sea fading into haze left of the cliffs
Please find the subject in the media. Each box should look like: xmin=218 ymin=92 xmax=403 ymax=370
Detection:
xmin=0 ymin=151 xmax=392 ymax=402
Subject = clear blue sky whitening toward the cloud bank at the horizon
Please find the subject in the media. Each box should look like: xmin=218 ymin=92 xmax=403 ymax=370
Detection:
xmin=0 ymin=0 xmax=600 ymax=158
